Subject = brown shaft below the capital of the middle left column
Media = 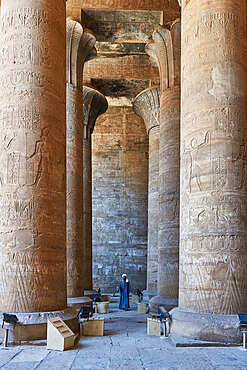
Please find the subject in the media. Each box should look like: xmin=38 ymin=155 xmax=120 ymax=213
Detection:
xmin=66 ymin=84 xmax=85 ymax=297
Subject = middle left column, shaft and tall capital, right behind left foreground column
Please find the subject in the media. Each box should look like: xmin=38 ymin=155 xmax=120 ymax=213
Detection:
xmin=66 ymin=19 xmax=96 ymax=297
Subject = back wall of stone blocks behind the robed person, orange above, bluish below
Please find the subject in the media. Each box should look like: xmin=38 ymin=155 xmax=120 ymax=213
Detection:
xmin=92 ymin=107 xmax=148 ymax=291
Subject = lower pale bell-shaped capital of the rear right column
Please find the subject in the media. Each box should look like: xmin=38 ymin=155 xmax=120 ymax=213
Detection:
xmin=133 ymin=87 xmax=160 ymax=133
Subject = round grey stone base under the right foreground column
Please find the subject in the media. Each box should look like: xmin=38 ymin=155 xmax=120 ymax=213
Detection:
xmin=171 ymin=307 xmax=242 ymax=343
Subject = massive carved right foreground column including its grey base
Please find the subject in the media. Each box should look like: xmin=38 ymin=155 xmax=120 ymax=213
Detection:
xmin=173 ymin=0 xmax=247 ymax=342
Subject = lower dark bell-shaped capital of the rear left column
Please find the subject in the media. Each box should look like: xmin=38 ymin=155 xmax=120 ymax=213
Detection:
xmin=83 ymin=86 xmax=108 ymax=134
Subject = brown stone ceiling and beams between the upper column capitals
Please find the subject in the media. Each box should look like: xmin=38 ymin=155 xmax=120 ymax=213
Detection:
xmin=67 ymin=0 xmax=180 ymax=104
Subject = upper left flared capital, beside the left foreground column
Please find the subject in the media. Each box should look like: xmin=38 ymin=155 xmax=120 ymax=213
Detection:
xmin=66 ymin=18 xmax=97 ymax=87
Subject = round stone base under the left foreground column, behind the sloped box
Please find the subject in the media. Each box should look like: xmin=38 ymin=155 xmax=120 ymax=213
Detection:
xmin=0 ymin=308 xmax=79 ymax=343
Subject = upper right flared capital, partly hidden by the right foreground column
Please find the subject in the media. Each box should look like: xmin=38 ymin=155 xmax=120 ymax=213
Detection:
xmin=153 ymin=19 xmax=181 ymax=92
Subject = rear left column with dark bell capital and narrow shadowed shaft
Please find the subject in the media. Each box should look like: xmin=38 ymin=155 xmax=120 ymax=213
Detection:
xmin=82 ymin=86 xmax=108 ymax=290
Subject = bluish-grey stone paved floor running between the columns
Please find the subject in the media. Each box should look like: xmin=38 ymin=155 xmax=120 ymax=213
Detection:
xmin=0 ymin=304 xmax=247 ymax=370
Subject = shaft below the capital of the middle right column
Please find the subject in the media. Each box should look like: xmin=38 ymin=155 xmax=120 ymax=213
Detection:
xmin=158 ymin=87 xmax=180 ymax=299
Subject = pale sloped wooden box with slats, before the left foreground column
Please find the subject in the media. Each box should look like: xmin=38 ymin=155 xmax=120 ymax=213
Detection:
xmin=47 ymin=317 xmax=75 ymax=351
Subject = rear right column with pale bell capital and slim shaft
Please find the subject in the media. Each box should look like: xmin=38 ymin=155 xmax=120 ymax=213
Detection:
xmin=133 ymin=88 xmax=160 ymax=291
